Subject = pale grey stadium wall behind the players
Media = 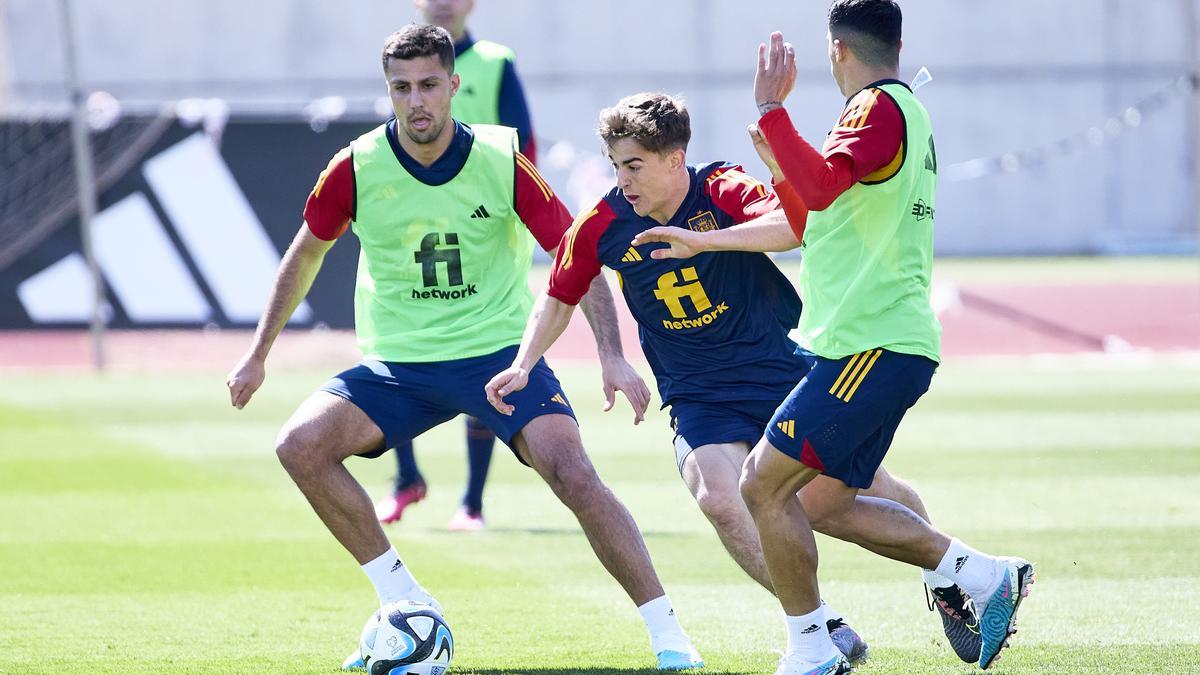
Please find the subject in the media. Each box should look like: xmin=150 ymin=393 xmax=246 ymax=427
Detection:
xmin=0 ymin=0 xmax=1195 ymax=255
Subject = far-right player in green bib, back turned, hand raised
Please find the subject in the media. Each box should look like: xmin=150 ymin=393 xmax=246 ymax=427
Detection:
xmin=635 ymin=0 xmax=1033 ymax=675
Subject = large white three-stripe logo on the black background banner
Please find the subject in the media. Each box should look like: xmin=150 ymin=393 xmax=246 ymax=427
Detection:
xmin=17 ymin=132 xmax=313 ymax=325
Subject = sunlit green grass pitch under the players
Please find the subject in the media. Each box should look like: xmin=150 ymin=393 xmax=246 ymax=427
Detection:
xmin=0 ymin=360 xmax=1200 ymax=675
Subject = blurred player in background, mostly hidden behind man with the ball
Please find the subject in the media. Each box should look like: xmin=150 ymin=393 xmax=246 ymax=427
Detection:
xmin=376 ymin=0 xmax=538 ymax=531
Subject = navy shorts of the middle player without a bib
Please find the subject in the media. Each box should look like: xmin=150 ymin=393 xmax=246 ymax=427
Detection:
xmin=671 ymin=394 xmax=786 ymax=473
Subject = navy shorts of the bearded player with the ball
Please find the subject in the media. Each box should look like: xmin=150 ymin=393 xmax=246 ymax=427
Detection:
xmin=320 ymin=346 xmax=575 ymax=459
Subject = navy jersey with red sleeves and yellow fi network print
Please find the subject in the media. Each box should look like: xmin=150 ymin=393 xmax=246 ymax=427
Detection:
xmin=548 ymin=162 xmax=804 ymax=406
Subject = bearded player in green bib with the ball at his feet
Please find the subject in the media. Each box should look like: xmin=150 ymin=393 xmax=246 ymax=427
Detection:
xmin=227 ymin=24 xmax=703 ymax=670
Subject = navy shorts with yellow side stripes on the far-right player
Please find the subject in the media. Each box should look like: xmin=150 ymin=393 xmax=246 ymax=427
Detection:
xmin=767 ymin=350 xmax=937 ymax=490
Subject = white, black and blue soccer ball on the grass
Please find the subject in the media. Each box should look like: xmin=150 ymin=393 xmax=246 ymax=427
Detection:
xmin=359 ymin=601 xmax=454 ymax=675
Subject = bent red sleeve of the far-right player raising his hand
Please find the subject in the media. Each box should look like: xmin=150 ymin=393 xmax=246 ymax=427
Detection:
xmin=758 ymin=89 xmax=904 ymax=210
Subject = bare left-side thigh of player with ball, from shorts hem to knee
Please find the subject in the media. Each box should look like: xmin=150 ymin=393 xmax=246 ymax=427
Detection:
xmin=276 ymin=390 xmax=384 ymax=461
